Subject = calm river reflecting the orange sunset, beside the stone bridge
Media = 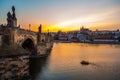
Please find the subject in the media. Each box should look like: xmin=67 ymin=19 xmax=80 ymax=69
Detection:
xmin=30 ymin=43 xmax=120 ymax=80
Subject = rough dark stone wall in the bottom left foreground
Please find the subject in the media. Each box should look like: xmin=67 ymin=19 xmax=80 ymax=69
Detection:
xmin=0 ymin=54 xmax=29 ymax=80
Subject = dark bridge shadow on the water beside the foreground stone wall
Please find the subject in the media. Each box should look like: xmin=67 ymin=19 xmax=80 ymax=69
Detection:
xmin=30 ymin=57 xmax=48 ymax=80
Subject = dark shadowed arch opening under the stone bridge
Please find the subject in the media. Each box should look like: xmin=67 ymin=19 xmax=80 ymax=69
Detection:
xmin=21 ymin=38 xmax=36 ymax=55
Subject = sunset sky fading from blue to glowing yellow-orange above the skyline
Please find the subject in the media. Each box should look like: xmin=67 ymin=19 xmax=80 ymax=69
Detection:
xmin=0 ymin=0 xmax=120 ymax=31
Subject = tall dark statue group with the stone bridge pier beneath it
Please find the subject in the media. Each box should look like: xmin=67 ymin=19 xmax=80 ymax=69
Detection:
xmin=3 ymin=6 xmax=17 ymax=45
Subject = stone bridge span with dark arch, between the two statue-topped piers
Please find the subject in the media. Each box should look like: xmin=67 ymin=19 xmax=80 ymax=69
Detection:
xmin=14 ymin=29 xmax=38 ymax=53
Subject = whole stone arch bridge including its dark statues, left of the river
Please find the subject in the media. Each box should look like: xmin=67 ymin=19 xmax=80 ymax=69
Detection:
xmin=0 ymin=6 xmax=50 ymax=53
